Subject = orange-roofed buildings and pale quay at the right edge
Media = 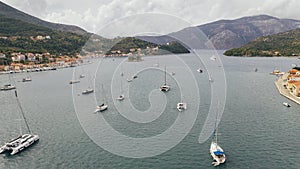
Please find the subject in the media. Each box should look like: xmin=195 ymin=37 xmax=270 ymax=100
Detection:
xmin=275 ymin=67 xmax=300 ymax=104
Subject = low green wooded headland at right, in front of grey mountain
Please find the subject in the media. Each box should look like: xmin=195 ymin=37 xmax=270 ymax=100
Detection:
xmin=224 ymin=29 xmax=300 ymax=56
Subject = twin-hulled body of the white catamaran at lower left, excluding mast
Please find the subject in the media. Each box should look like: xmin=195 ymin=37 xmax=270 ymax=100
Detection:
xmin=0 ymin=134 xmax=40 ymax=155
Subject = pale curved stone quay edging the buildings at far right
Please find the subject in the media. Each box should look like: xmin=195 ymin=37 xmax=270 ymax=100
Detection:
xmin=274 ymin=73 xmax=300 ymax=105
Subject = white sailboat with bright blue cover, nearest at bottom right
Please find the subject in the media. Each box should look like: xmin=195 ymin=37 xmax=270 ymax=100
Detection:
xmin=209 ymin=112 xmax=226 ymax=166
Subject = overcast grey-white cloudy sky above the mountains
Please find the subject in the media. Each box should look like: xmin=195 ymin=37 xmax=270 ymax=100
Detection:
xmin=2 ymin=0 xmax=300 ymax=33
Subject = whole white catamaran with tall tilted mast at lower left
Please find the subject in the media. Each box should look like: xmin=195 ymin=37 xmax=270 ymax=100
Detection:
xmin=0 ymin=91 xmax=40 ymax=155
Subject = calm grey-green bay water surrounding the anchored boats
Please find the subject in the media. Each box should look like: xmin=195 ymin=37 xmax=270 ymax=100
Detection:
xmin=0 ymin=51 xmax=300 ymax=169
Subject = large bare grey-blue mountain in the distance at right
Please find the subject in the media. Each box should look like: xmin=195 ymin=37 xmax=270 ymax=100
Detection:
xmin=138 ymin=15 xmax=300 ymax=49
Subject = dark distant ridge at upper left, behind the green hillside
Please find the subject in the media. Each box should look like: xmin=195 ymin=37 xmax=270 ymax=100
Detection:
xmin=0 ymin=1 xmax=88 ymax=35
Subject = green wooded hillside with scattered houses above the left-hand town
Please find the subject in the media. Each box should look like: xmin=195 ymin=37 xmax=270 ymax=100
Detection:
xmin=0 ymin=15 xmax=88 ymax=56
